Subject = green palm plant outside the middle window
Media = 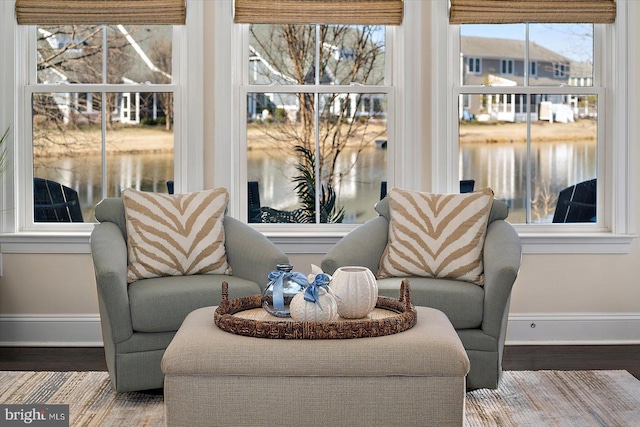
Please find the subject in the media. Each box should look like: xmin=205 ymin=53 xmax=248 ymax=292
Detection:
xmin=293 ymin=145 xmax=344 ymax=223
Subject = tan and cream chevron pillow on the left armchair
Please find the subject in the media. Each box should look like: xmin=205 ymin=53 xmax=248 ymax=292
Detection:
xmin=122 ymin=188 xmax=231 ymax=283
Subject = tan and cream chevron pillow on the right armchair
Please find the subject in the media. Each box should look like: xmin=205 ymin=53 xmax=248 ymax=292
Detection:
xmin=378 ymin=188 xmax=493 ymax=285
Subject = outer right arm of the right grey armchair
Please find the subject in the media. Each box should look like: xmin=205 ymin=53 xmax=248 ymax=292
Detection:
xmin=482 ymin=220 xmax=522 ymax=338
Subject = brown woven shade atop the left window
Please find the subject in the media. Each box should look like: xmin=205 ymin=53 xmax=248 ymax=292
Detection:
xmin=16 ymin=0 xmax=187 ymax=25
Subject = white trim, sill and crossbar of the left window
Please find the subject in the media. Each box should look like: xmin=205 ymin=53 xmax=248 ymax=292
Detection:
xmin=0 ymin=0 xmax=204 ymax=253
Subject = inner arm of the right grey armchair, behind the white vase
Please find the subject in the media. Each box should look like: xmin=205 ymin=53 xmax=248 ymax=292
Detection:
xmin=321 ymin=216 xmax=389 ymax=274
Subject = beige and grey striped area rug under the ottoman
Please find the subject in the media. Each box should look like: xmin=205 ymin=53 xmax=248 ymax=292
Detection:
xmin=0 ymin=371 xmax=640 ymax=427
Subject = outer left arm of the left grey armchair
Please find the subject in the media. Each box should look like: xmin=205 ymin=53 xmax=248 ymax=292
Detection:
xmin=91 ymin=222 xmax=133 ymax=343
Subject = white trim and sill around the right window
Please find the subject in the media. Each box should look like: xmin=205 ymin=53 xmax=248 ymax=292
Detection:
xmin=432 ymin=0 xmax=637 ymax=254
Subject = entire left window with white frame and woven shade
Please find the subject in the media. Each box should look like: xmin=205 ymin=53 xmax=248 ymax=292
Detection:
xmin=0 ymin=0 xmax=202 ymax=241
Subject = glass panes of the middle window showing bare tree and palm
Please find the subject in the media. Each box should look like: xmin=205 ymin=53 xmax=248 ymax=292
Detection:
xmin=241 ymin=24 xmax=392 ymax=224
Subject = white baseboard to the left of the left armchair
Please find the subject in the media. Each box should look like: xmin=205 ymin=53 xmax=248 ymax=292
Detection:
xmin=0 ymin=314 xmax=103 ymax=347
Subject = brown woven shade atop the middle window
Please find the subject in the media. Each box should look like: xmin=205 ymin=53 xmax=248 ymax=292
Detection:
xmin=234 ymin=0 xmax=404 ymax=25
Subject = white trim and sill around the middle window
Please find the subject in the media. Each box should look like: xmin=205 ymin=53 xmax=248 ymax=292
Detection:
xmin=214 ymin=2 xmax=426 ymax=254
